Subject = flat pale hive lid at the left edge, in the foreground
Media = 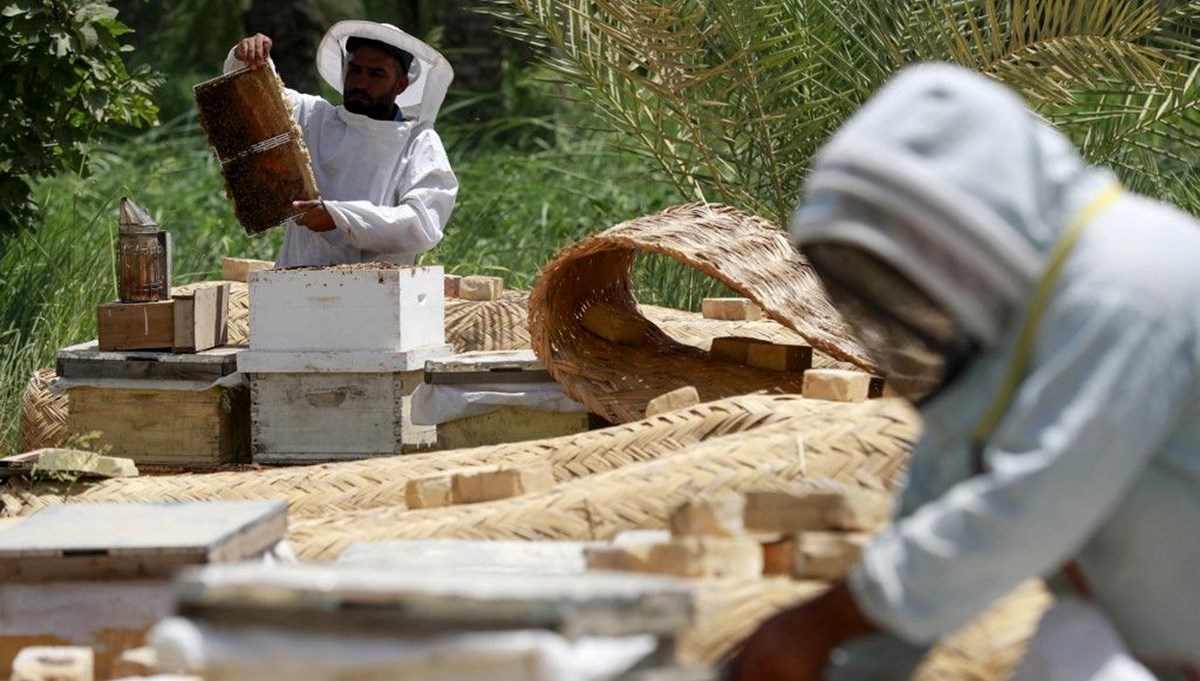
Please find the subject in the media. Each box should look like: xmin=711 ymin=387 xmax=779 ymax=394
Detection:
xmin=0 ymin=501 xmax=287 ymax=581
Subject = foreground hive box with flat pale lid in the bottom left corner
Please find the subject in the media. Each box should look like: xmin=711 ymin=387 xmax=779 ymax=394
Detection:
xmin=0 ymin=501 xmax=287 ymax=679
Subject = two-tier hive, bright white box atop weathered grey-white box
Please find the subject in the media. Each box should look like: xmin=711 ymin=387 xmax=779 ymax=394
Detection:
xmin=238 ymin=264 xmax=451 ymax=464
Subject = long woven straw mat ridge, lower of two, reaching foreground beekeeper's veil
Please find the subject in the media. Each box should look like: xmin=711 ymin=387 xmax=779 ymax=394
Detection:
xmin=288 ymin=399 xmax=917 ymax=559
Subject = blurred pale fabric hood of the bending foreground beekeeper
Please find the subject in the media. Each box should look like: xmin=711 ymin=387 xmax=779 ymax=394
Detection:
xmin=790 ymin=64 xmax=1115 ymax=349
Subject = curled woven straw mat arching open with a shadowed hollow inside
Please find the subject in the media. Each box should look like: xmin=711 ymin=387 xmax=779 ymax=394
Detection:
xmin=529 ymin=199 xmax=872 ymax=423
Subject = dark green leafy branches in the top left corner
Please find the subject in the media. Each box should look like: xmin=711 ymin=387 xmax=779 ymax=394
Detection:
xmin=0 ymin=0 xmax=158 ymax=233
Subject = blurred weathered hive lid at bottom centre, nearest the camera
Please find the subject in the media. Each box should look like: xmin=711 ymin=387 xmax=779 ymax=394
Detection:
xmin=176 ymin=564 xmax=692 ymax=638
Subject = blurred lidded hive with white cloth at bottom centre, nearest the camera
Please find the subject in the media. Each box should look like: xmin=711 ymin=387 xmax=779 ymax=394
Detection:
xmin=155 ymin=565 xmax=694 ymax=681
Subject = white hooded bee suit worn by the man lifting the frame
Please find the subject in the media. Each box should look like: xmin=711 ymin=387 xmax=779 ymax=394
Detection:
xmin=224 ymin=20 xmax=458 ymax=267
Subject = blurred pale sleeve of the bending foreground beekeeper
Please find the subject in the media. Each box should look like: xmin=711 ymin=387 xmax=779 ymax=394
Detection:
xmin=850 ymin=282 xmax=1195 ymax=643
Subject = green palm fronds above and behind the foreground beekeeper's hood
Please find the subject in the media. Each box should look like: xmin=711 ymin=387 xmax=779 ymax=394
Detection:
xmin=488 ymin=0 xmax=1200 ymax=222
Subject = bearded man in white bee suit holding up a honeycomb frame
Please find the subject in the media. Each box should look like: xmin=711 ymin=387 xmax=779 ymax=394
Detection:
xmin=224 ymin=20 xmax=458 ymax=266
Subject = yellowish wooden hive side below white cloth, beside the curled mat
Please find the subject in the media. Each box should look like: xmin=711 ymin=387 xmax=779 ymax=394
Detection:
xmin=437 ymin=406 xmax=589 ymax=450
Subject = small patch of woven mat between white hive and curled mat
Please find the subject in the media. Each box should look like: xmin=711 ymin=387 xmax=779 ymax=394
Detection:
xmin=445 ymin=291 xmax=529 ymax=352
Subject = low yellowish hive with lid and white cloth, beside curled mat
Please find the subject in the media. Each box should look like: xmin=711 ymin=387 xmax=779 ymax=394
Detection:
xmin=418 ymin=350 xmax=590 ymax=450
